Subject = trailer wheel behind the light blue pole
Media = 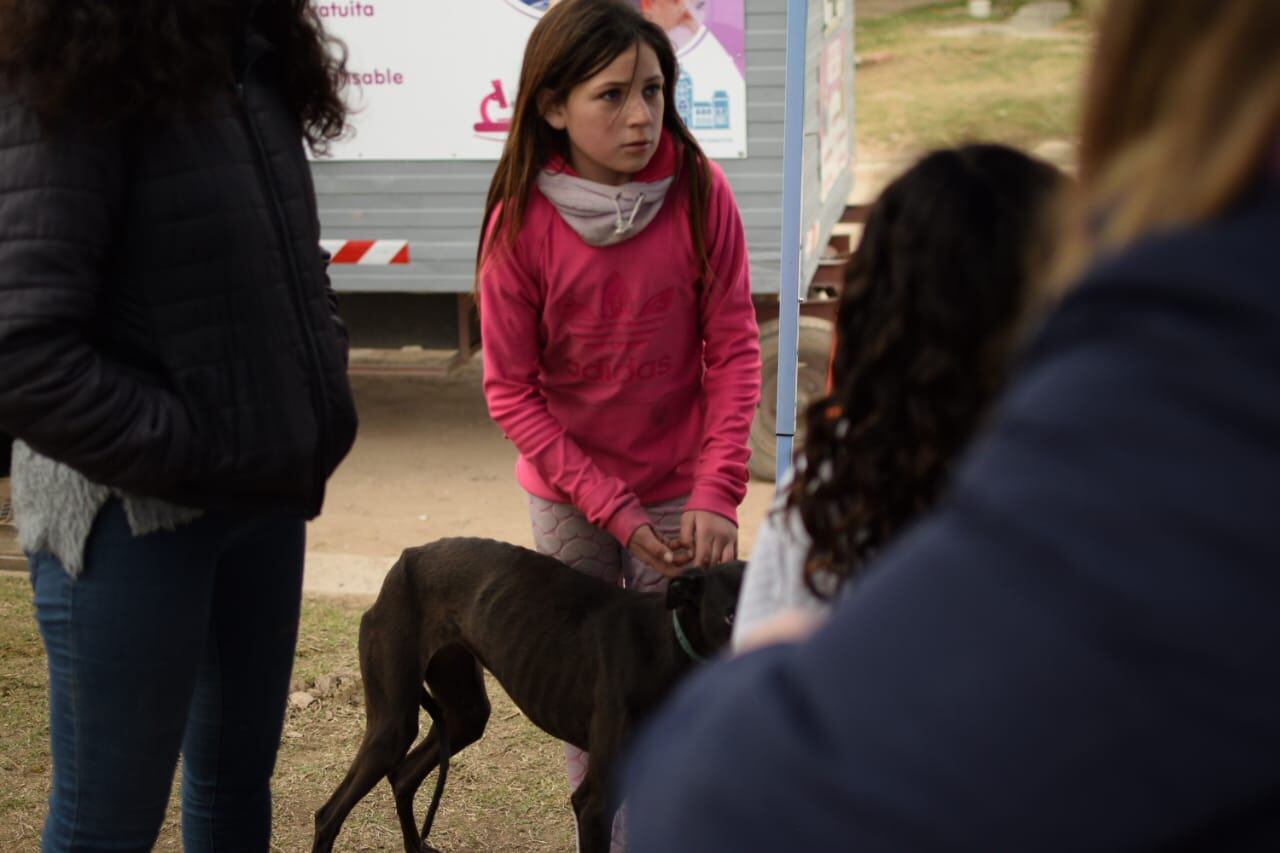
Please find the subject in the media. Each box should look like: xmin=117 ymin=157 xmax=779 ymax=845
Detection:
xmin=748 ymin=316 xmax=835 ymax=482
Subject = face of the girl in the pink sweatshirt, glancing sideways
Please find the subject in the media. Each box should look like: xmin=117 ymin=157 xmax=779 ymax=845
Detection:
xmin=543 ymin=44 xmax=666 ymax=184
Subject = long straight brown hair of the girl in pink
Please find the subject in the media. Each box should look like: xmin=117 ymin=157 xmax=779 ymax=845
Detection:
xmin=476 ymin=0 xmax=712 ymax=282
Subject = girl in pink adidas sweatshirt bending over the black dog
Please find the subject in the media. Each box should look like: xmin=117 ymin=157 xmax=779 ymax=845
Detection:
xmin=479 ymin=0 xmax=760 ymax=845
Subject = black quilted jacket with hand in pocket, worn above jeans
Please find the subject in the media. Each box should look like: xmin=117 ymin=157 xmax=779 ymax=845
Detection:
xmin=0 ymin=31 xmax=356 ymax=517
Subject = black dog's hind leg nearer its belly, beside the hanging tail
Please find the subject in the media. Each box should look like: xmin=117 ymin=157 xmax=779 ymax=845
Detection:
xmin=390 ymin=646 xmax=490 ymax=849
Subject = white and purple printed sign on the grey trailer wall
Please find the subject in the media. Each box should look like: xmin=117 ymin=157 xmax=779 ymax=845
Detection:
xmin=315 ymin=0 xmax=746 ymax=160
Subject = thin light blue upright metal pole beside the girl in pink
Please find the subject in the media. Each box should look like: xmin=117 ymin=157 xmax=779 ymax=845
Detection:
xmin=774 ymin=0 xmax=809 ymax=483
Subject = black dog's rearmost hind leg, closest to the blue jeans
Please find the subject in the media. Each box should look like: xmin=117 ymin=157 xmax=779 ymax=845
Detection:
xmin=311 ymin=611 xmax=421 ymax=853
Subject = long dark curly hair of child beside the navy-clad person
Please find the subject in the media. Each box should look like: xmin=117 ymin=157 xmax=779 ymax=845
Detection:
xmin=786 ymin=145 xmax=1064 ymax=597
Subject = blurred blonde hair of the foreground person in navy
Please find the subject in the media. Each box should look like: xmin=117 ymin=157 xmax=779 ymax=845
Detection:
xmin=1053 ymin=0 xmax=1280 ymax=284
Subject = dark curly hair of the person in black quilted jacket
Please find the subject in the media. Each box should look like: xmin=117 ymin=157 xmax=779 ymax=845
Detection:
xmin=0 ymin=0 xmax=347 ymax=150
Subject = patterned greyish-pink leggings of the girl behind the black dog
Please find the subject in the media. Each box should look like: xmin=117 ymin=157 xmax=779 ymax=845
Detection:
xmin=529 ymin=494 xmax=687 ymax=853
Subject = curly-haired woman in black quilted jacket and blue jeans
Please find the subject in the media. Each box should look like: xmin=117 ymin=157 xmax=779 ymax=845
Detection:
xmin=0 ymin=0 xmax=356 ymax=850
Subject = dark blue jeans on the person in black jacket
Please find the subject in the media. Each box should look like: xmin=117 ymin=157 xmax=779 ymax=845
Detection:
xmin=29 ymin=500 xmax=305 ymax=853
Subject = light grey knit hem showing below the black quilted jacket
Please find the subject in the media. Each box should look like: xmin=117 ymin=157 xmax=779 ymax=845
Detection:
xmin=9 ymin=441 xmax=201 ymax=578
